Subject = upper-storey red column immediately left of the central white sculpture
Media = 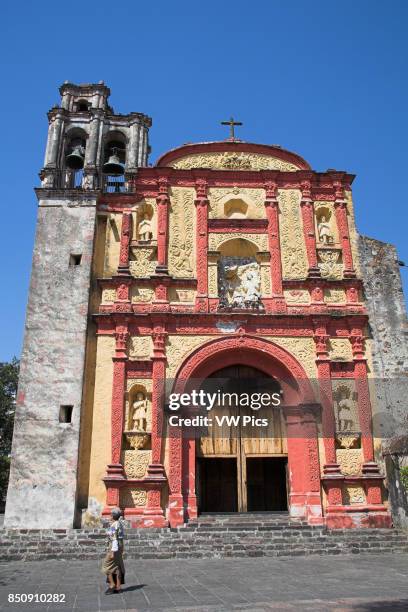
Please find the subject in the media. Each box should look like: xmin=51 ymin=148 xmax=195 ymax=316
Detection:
xmin=194 ymin=179 xmax=208 ymax=312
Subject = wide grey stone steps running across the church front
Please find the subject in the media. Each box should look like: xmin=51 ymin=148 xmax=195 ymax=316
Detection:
xmin=0 ymin=513 xmax=408 ymax=561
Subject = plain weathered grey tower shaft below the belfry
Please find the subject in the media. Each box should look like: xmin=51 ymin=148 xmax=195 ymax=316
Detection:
xmin=5 ymin=194 xmax=96 ymax=528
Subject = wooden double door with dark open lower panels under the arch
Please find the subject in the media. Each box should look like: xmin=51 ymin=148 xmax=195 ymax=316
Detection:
xmin=196 ymin=365 xmax=288 ymax=512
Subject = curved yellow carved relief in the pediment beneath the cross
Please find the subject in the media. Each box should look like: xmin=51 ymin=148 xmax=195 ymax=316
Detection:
xmin=169 ymin=152 xmax=299 ymax=172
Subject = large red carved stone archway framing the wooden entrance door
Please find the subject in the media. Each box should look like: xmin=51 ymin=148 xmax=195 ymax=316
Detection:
xmin=168 ymin=332 xmax=322 ymax=525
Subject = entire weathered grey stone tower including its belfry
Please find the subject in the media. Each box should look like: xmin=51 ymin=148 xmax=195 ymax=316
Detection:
xmin=5 ymin=81 xmax=151 ymax=528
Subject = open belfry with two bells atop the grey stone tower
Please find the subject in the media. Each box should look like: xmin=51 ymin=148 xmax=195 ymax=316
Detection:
xmin=40 ymin=81 xmax=151 ymax=192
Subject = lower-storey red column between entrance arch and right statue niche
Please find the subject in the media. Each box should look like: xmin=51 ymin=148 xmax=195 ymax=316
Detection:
xmin=314 ymin=319 xmax=343 ymax=511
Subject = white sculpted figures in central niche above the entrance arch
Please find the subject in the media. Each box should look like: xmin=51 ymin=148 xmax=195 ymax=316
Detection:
xmin=220 ymin=262 xmax=262 ymax=309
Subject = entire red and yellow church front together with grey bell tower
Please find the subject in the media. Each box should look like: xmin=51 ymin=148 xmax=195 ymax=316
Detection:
xmin=5 ymin=83 xmax=406 ymax=528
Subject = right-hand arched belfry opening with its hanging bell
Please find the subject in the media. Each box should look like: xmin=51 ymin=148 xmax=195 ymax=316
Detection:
xmin=102 ymin=131 xmax=127 ymax=193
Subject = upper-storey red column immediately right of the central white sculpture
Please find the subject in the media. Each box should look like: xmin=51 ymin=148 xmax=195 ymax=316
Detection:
xmin=265 ymin=181 xmax=283 ymax=300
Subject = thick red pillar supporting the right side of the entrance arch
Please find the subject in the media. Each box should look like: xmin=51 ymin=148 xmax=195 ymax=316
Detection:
xmin=284 ymin=404 xmax=323 ymax=524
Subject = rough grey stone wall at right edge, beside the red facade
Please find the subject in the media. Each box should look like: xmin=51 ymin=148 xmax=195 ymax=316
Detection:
xmin=359 ymin=236 xmax=408 ymax=439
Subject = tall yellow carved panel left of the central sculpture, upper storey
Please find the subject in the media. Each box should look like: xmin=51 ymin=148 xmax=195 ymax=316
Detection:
xmin=169 ymin=187 xmax=195 ymax=278
